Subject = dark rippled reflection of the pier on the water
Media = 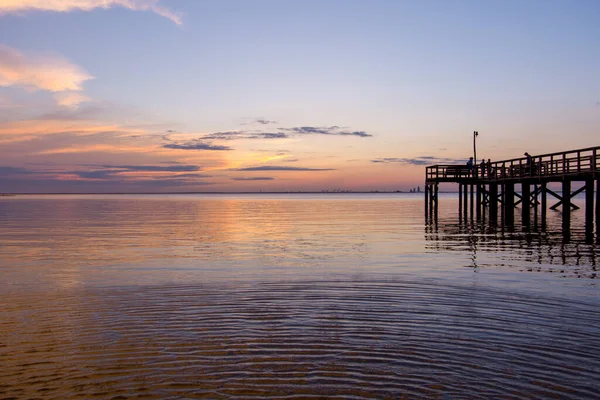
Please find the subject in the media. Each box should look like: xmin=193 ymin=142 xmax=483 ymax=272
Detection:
xmin=425 ymin=196 xmax=598 ymax=279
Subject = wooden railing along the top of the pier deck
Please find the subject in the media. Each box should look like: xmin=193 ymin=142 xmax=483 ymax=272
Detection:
xmin=425 ymin=146 xmax=600 ymax=182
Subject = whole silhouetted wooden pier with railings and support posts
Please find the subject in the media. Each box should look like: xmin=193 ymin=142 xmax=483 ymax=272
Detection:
xmin=425 ymin=146 xmax=600 ymax=240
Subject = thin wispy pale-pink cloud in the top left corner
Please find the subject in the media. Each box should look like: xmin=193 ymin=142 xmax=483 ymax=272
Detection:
xmin=0 ymin=0 xmax=182 ymax=25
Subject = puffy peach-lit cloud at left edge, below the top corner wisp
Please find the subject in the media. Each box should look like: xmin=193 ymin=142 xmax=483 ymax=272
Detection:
xmin=0 ymin=43 xmax=93 ymax=92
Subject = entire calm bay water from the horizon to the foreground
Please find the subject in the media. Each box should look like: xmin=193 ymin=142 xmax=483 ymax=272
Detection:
xmin=0 ymin=194 xmax=600 ymax=399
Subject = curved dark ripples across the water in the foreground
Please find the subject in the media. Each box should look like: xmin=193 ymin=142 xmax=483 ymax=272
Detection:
xmin=0 ymin=280 xmax=600 ymax=399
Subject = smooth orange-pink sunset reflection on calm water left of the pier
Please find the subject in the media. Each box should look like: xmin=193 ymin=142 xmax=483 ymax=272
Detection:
xmin=0 ymin=196 xmax=432 ymax=290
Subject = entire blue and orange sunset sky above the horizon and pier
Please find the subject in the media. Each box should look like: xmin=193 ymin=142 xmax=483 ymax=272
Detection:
xmin=0 ymin=0 xmax=600 ymax=193
